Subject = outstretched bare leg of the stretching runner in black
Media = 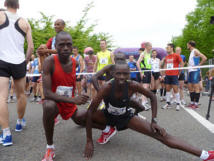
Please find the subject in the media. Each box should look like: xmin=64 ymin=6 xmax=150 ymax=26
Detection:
xmin=128 ymin=116 xmax=202 ymax=157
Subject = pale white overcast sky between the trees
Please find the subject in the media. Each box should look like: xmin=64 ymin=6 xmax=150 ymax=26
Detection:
xmin=0 ymin=0 xmax=197 ymax=48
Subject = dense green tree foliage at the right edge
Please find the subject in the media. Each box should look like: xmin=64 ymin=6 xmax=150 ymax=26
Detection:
xmin=172 ymin=0 xmax=214 ymax=58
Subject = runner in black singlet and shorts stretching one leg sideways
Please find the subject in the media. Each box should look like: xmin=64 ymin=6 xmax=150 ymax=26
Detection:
xmin=85 ymin=63 xmax=214 ymax=161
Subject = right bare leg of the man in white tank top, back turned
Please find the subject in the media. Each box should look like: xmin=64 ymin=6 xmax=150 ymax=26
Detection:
xmin=14 ymin=77 xmax=27 ymax=119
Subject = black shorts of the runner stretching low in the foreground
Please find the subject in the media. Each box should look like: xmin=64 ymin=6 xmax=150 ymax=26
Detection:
xmin=103 ymin=109 xmax=135 ymax=131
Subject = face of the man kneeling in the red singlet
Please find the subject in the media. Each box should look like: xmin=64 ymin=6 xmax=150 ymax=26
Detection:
xmin=56 ymin=35 xmax=72 ymax=58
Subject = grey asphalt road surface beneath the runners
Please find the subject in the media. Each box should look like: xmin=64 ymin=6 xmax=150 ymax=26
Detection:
xmin=0 ymin=93 xmax=214 ymax=161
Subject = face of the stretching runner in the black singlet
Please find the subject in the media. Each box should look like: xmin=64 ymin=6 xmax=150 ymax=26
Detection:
xmin=114 ymin=64 xmax=130 ymax=85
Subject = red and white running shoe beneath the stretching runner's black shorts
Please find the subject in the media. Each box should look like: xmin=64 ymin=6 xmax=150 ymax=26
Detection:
xmin=97 ymin=127 xmax=117 ymax=144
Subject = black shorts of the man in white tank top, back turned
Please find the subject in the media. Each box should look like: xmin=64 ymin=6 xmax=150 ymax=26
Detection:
xmin=0 ymin=60 xmax=26 ymax=80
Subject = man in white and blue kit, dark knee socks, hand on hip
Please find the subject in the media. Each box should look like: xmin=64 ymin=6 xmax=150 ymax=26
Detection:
xmin=187 ymin=40 xmax=207 ymax=109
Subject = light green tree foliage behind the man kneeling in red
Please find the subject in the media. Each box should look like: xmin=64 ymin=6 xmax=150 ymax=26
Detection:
xmin=25 ymin=3 xmax=113 ymax=53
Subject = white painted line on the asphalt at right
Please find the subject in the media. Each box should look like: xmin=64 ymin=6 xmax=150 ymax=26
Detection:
xmin=183 ymin=107 xmax=214 ymax=133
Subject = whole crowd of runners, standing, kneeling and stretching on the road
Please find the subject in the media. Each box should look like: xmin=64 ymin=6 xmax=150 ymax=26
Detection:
xmin=0 ymin=0 xmax=214 ymax=161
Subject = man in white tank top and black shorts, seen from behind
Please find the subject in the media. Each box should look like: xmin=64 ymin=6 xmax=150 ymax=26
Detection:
xmin=0 ymin=0 xmax=34 ymax=146
